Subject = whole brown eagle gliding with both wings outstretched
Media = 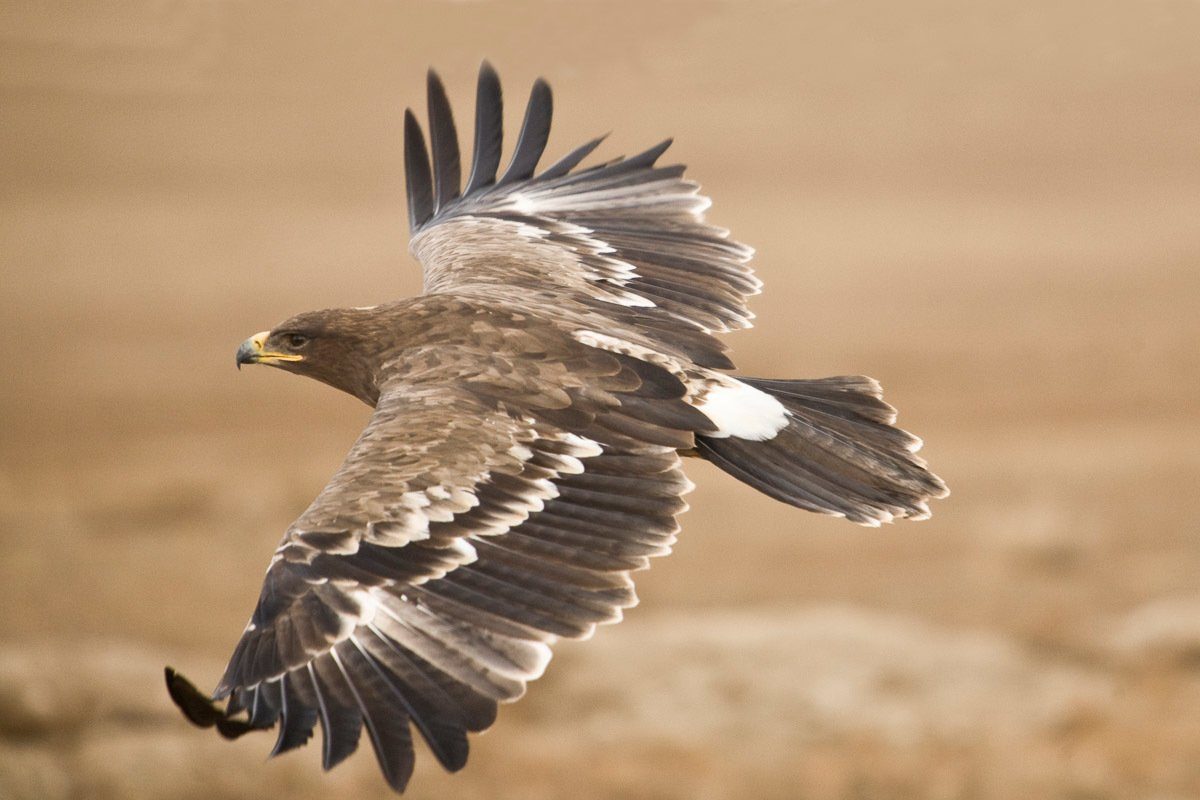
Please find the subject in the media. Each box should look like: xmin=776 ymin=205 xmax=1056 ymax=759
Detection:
xmin=167 ymin=62 xmax=947 ymax=792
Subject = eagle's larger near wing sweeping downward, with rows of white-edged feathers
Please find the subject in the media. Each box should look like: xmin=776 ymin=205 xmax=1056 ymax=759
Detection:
xmin=216 ymin=331 xmax=707 ymax=789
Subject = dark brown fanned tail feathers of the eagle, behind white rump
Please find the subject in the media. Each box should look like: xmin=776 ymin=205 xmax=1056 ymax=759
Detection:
xmin=696 ymin=375 xmax=949 ymax=525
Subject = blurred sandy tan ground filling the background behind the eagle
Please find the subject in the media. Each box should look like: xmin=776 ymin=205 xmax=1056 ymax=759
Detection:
xmin=0 ymin=0 xmax=1200 ymax=800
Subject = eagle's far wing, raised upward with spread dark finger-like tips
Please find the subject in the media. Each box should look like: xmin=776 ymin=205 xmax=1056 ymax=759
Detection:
xmin=404 ymin=62 xmax=761 ymax=333
